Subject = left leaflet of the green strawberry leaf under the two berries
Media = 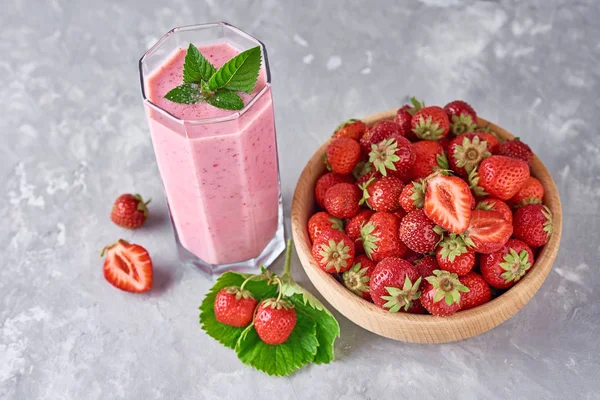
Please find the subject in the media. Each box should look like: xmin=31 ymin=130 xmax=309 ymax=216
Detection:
xmin=200 ymin=272 xmax=277 ymax=349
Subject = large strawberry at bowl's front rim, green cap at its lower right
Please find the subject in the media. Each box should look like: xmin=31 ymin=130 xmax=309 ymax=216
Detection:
xmin=369 ymin=257 xmax=421 ymax=312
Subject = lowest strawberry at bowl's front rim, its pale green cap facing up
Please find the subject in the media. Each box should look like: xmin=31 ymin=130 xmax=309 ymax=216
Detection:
xmin=421 ymin=269 xmax=469 ymax=317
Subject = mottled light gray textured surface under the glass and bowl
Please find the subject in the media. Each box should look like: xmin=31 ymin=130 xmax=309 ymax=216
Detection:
xmin=0 ymin=0 xmax=600 ymax=400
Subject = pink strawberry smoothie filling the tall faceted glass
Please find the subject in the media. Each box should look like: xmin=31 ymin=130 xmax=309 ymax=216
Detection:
xmin=145 ymin=43 xmax=279 ymax=264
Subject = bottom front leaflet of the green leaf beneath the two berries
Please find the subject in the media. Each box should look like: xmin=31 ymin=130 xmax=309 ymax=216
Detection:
xmin=235 ymin=311 xmax=319 ymax=376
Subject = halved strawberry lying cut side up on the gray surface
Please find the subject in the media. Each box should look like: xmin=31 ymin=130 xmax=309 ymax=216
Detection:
xmin=100 ymin=239 xmax=152 ymax=293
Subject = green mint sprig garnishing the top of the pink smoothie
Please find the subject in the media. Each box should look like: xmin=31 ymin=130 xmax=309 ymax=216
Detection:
xmin=165 ymin=43 xmax=262 ymax=110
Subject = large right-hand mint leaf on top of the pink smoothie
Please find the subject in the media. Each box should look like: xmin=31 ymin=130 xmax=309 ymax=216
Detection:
xmin=208 ymin=46 xmax=262 ymax=93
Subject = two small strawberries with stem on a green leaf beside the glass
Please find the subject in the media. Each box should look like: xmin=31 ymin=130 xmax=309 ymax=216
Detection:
xmin=200 ymin=240 xmax=340 ymax=376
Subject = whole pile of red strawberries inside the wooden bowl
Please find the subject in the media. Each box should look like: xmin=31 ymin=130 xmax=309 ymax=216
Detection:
xmin=308 ymin=98 xmax=552 ymax=316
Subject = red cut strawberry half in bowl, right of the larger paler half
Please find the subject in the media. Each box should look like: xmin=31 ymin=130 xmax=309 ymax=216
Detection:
xmin=464 ymin=210 xmax=513 ymax=254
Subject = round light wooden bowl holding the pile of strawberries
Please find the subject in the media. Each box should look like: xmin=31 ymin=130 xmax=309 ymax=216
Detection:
xmin=292 ymin=109 xmax=562 ymax=343
